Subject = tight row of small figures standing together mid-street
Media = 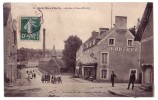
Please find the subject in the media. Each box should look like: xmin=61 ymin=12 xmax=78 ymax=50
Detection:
xmin=41 ymin=74 xmax=62 ymax=84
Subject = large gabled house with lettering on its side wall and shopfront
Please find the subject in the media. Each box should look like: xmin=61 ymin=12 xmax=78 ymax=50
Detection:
xmin=76 ymin=16 xmax=141 ymax=82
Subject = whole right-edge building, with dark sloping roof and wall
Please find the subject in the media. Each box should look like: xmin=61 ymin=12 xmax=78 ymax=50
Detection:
xmin=135 ymin=3 xmax=154 ymax=89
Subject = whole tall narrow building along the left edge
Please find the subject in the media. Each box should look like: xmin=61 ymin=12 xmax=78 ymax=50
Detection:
xmin=3 ymin=3 xmax=17 ymax=83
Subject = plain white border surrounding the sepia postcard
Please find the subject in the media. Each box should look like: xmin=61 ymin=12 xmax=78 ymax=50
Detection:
xmin=0 ymin=0 xmax=158 ymax=100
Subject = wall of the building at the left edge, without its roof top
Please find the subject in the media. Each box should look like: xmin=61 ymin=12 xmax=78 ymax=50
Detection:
xmin=4 ymin=9 xmax=17 ymax=82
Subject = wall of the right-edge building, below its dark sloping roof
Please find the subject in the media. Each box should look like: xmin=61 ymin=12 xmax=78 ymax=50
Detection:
xmin=141 ymin=8 xmax=154 ymax=86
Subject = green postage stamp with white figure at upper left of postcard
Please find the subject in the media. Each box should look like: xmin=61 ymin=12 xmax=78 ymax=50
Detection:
xmin=20 ymin=17 xmax=40 ymax=40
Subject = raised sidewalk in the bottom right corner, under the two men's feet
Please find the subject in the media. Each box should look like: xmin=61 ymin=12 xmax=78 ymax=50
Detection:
xmin=108 ymin=83 xmax=153 ymax=97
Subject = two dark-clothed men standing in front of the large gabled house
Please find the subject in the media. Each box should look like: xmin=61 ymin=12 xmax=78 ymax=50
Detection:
xmin=111 ymin=71 xmax=136 ymax=90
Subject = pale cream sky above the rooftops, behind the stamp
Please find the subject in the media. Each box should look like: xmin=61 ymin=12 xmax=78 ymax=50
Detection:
xmin=11 ymin=2 xmax=146 ymax=50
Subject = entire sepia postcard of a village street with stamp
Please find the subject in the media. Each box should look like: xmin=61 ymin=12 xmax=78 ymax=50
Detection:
xmin=3 ymin=2 xmax=154 ymax=97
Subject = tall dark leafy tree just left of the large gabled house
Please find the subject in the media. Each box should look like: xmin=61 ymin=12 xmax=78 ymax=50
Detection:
xmin=62 ymin=35 xmax=82 ymax=73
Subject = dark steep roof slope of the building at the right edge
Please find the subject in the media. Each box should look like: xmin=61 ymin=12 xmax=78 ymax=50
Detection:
xmin=135 ymin=3 xmax=153 ymax=41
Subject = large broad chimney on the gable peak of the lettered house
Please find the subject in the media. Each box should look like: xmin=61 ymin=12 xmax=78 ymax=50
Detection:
xmin=115 ymin=16 xmax=127 ymax=29
